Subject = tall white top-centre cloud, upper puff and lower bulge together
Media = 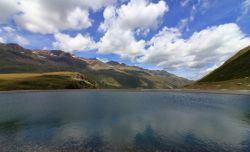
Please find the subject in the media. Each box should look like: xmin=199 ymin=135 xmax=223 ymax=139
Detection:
xmin=97 ymin=0 xmax=168 ymax=59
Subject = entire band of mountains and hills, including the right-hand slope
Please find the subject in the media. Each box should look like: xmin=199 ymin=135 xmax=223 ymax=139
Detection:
xmin=0 ymin=43 xmax=250 ymax=90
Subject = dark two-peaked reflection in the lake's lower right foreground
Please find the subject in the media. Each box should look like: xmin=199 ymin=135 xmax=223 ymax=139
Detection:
xmin=135 ymin=127 xmax=237 ymax=152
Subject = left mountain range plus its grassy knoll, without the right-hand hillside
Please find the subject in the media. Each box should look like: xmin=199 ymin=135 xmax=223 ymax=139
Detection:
xmin=0 ymin=43 xmax=193 ymax=90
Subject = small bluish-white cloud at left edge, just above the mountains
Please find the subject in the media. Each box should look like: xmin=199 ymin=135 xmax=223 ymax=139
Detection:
xmin=1 ymin=26 xmax=29 ymax=45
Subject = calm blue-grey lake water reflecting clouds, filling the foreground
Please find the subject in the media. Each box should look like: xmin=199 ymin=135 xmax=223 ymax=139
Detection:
xmin=0 ymin=91 xmax=250 ymax=152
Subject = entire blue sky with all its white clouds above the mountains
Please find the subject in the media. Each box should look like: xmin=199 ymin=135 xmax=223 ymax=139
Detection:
xmin=0 ymin=0 xmax=250 ymax=79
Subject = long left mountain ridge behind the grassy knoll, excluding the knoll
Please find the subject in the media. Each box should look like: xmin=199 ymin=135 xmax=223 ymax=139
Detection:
xmin=0 ymin=44 xmax=192 ymax=89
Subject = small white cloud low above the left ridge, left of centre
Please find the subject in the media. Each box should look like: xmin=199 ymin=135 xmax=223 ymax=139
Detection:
xmin=53 ymin=33 xmax=95 ymax=52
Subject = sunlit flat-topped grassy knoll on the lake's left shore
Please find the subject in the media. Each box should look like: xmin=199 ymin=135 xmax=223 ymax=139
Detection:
xmin=0 ymin=72 xmax=95 ymax=91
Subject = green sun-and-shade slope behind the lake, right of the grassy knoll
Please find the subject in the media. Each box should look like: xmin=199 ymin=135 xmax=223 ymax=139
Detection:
xmin=83 ymin=68 xmax=191 ymax=89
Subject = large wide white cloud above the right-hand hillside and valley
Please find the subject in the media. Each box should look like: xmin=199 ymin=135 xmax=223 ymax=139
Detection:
xmin=139 ymin=23 xmax=250 ymax=79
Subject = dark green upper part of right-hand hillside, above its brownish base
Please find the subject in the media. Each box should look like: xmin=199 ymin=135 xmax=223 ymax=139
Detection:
xmin=199 ymin=46 xmax=250 ymax=82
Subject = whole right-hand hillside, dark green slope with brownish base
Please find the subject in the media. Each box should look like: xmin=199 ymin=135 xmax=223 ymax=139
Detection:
xmin=187 ymin=46 xmax=250 ymax=90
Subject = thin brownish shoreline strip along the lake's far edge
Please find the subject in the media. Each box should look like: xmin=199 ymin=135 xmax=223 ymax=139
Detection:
xmin=0 ymin=89 xmax=250 ymax=95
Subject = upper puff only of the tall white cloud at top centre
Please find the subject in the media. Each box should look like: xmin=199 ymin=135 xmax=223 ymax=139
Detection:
xmin=101 ymin=0 xmax=168 ymax=30
